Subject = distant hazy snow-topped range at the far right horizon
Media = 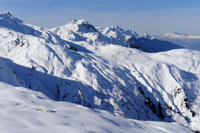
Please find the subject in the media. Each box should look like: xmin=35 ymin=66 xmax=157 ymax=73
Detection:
xmin=159 ymin=32 xmax=200 ymax=50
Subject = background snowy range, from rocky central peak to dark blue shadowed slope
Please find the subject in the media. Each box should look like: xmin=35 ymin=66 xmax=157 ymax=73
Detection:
xmin=50 ymin=20 xmax=182 ymax=52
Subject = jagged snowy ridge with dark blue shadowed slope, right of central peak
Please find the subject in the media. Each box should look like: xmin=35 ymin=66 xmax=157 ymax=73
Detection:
xmin=97 ymin=25 xmax=182 ymax=52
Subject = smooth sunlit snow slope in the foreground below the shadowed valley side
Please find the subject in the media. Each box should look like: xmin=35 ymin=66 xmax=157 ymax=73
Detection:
xmin=0 ymin=80 xmax=192 ymax=133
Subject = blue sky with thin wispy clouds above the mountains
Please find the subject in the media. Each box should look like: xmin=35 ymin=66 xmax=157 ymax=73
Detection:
xmin=0 ymin=0 xmax=200 ymax=36
